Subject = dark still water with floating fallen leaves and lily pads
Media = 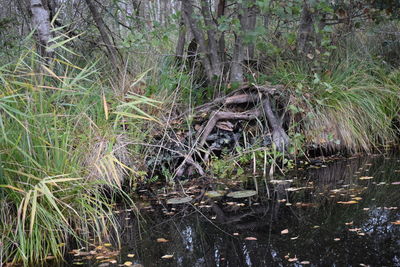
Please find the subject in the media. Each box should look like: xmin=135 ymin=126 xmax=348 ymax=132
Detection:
xmin=62 ymin=156 xmax=400 ymax=267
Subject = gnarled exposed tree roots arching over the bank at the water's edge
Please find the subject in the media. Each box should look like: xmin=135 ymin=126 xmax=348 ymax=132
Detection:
xmin=148 ymin=84 xmax=290 ymax=179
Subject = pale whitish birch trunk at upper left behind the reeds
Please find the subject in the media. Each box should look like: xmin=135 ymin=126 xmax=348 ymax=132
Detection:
xmin=30 ymin=0 xmax=54 ymax=61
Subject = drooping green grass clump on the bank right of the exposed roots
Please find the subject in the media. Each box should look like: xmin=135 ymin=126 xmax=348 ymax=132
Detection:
xmin=269 ymin=29 xmax=400 ymax=152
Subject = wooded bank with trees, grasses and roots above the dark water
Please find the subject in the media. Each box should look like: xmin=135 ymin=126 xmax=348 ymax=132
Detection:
xmin=0 ymin=0 xmax=400 ymax=266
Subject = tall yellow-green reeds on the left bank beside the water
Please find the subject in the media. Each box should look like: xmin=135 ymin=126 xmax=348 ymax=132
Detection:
xmin=0 ymin=45 xmax=157 ymax=264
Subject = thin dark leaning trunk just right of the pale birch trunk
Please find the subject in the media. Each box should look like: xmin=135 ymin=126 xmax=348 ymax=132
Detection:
xmin=85 ymin=0 xmax=121 ymax=72
